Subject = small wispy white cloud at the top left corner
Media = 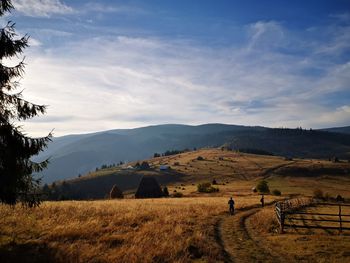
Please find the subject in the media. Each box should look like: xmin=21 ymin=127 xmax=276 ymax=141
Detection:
xmin=13 ymin=0 xmax=74 ymax=17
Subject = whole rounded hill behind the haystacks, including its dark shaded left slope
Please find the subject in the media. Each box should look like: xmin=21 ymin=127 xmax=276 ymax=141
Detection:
xmin=53 ymin=149 xmax=350 ymax=199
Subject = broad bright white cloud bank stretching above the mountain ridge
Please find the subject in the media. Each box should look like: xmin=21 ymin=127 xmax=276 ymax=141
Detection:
xmin=18 ymin=19 xmax=350 ymax=135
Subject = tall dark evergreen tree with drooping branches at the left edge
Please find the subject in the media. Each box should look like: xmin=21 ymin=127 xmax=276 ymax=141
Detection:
xmin=0 ymin=0 xmax=51 ymax=206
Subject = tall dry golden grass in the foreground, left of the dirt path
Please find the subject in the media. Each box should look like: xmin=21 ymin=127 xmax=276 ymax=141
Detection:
xmin=0 ymin=196 xmax=272 ymax=262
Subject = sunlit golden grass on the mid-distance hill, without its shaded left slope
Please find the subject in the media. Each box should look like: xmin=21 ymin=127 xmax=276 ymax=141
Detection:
xmin=69 ymin=149 xmax=350 ymax=198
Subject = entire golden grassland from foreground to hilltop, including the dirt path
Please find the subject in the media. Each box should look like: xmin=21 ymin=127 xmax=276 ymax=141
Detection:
xmin=0 ymin=149 xmax=350 ymax=262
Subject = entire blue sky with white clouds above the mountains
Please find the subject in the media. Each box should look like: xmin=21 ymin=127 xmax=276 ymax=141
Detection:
xmin=0 ymin=0 xmax=350 ymax=136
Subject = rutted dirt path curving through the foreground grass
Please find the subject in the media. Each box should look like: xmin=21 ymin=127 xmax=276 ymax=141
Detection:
xmin=217 ymin=207 xmax=281 ymax=262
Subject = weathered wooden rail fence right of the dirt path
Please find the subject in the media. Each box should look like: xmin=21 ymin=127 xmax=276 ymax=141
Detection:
xmin=275 ymin=201 xmax=350 ymax=233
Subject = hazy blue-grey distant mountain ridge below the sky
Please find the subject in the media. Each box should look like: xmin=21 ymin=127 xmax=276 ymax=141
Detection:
xmin=35 ymin=124 xmax=350 ymax=183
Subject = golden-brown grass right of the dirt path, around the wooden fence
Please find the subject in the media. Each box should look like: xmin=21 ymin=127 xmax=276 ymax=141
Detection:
xmin=247 ymin=206 xmax=350 ymax=262
